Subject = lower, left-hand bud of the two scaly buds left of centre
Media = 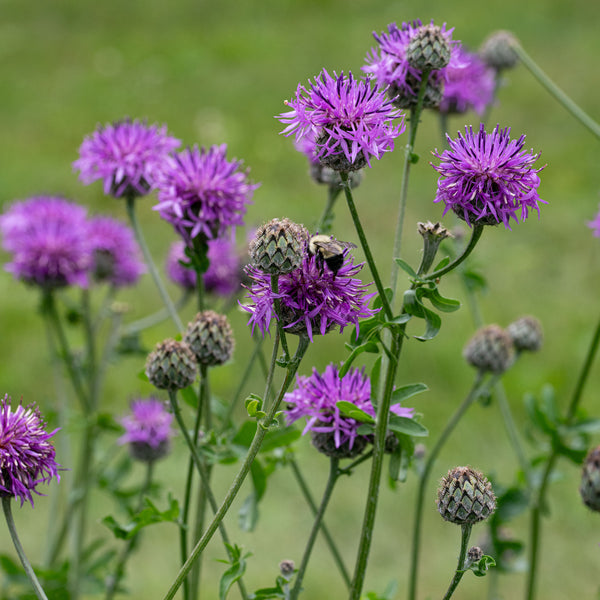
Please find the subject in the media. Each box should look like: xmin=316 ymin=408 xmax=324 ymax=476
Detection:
xmin=146 ymin=339 xmax=198 ymax=391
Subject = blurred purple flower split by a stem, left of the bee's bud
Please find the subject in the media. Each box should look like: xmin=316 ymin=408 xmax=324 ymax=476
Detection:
xmin=166 ymin=238 xmax=242 ymax=297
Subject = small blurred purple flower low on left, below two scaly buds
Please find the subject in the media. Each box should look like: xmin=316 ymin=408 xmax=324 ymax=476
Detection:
xmin=118 ymin=397 xmax=174 ymax=462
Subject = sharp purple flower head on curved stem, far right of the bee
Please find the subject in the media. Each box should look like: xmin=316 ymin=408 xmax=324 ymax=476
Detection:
xmin=432 ymin=123 xmax=546 ymax=229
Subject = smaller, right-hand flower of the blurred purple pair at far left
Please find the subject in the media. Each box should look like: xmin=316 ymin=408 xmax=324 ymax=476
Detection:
xmin=88 ymin=217 xmax=146 ymax=287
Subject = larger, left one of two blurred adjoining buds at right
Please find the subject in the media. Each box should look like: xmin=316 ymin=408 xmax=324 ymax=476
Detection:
xmin=463 ymin=325 xmax=515 ymax=375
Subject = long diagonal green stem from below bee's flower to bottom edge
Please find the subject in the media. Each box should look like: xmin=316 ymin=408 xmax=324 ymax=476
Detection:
xmin=164 ymin=336 xmax=308 ymax=600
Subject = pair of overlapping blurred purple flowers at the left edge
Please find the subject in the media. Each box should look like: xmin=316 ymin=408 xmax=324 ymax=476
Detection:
xmin=0 ymin=196 xmax=145 ymax=289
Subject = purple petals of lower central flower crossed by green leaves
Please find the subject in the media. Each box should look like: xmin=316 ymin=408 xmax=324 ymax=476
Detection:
xmin=284 ymin=365 xmax=414 ymax=448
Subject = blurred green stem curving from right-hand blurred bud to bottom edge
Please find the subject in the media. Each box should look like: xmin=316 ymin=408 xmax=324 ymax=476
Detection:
xmin=408 ymin=371 xmax=492 ymax=600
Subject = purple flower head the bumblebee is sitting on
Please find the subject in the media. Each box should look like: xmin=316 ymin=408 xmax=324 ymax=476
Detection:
xmin=242 ymin=250 xmax=377 ymax=342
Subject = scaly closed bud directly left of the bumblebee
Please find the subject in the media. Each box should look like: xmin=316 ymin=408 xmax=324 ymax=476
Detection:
xmin=250 ymin=219 xmax=309 ymax=275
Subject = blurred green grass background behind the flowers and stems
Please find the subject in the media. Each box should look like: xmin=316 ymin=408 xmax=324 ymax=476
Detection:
xmin=0 ymin=0 xmax=600 ymax=600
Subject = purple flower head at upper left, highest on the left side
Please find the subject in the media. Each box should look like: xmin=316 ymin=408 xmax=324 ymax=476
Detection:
xmin=73 ymin=119 xmax=181 ymax=198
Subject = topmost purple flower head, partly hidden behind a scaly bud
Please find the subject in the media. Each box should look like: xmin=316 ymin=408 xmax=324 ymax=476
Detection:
xmin=363 ymin=20 xmax=460 ymax=108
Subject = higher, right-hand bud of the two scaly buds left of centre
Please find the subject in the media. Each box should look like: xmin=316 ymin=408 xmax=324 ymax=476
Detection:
xmin=183 ymin=310 xmax=235 ymax=366
